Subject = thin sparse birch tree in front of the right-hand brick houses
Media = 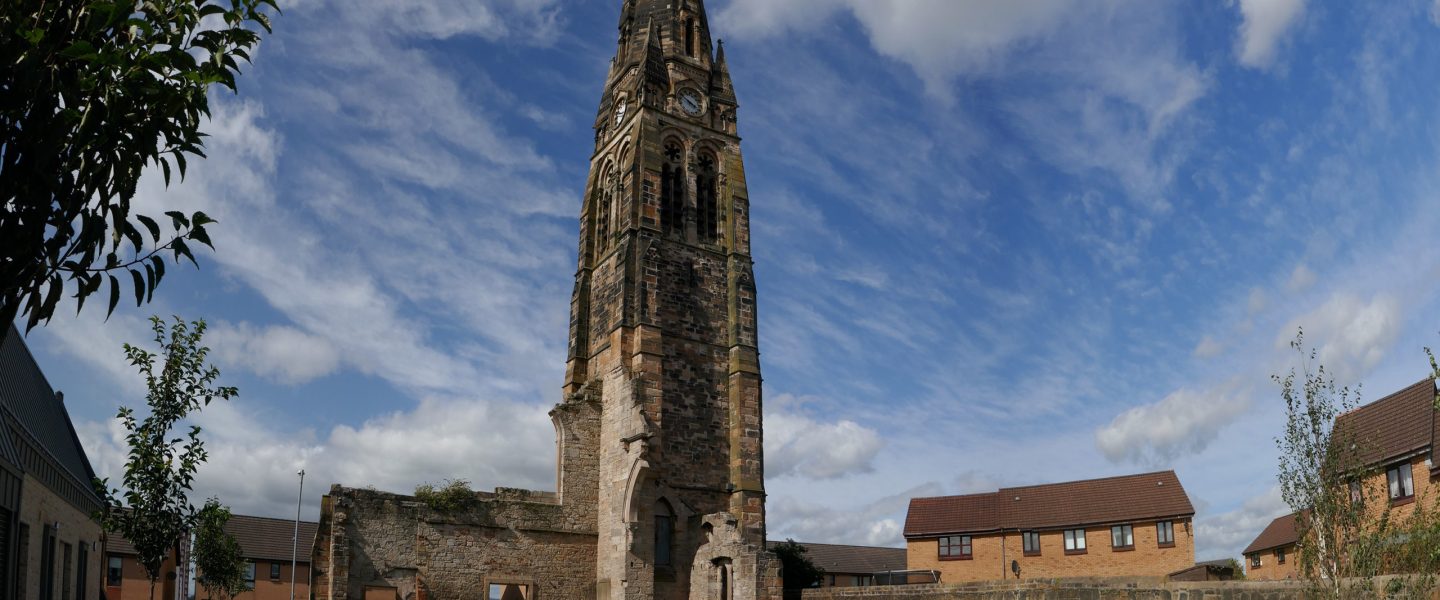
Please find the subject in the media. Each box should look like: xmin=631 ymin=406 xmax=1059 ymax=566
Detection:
xmin=1274 ymin=329 xmax=1372 ymax=597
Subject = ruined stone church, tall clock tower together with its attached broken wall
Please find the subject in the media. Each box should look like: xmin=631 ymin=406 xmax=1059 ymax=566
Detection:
xmin=312 ymin=0 xmax=780 ymax=600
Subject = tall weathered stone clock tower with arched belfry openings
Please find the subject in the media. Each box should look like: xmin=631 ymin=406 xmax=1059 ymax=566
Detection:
xmin=564 ymin=0 xmax=766 ymax=600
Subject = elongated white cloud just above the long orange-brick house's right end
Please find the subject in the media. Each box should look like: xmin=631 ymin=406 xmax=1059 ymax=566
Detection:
xmin=1094 ymin=390 xmax=1250 ymax=466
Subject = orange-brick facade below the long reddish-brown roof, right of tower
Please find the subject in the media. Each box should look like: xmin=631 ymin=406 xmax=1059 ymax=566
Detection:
xmin=906 ymin=519 xmax=1195 ymax=583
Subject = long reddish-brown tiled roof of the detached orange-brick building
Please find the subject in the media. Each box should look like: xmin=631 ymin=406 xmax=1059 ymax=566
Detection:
xmin=904 ymin=471 xmax=1195 ymax=538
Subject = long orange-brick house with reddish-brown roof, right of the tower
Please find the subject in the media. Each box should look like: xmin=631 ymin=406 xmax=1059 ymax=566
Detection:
xmin=904 ymin=471 xmax=1195 ymax=583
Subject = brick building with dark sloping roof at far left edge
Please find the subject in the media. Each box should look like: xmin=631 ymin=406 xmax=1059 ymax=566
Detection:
xmin=0 ymin=324 xmax=102 ymax=600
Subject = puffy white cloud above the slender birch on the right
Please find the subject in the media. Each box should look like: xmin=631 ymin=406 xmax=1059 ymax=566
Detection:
xmin=1276 ymin=292 xmax=1404 ymax=384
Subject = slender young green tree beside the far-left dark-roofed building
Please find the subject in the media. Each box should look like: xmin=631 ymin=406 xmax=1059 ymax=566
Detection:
xmin=96 ymin=317 xmax=236 ymax=596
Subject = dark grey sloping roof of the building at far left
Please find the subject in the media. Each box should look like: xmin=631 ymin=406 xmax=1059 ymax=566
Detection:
xmin=0 ymin=324 xmax=99 ymax=502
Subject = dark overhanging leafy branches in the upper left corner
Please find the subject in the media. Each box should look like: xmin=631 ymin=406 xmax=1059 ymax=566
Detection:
xmin=0 ymin=0 xmax=278 ymax=337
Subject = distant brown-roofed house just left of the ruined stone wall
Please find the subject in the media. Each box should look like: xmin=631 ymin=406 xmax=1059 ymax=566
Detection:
xmin=196 ymin=515 xmax=317 ymax=600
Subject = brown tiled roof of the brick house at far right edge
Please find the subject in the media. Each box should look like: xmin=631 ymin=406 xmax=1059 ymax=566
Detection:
xmin=1335 ymin=378 xmax=1440 ymax=465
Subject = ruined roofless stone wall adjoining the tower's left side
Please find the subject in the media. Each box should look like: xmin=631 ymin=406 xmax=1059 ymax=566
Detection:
xmin=311 ymin=393 xmax=599 ymax=600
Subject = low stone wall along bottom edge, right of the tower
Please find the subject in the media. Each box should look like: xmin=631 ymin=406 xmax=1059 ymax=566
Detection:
xmin=804 ymin=577 xmax=1440 ymax=600
